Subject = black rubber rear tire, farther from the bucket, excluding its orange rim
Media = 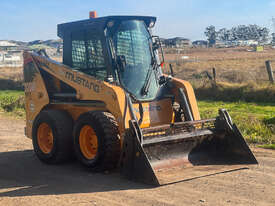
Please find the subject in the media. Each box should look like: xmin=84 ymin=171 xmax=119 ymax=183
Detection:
xmin=32 ymin=110 xmax=73 ymax=164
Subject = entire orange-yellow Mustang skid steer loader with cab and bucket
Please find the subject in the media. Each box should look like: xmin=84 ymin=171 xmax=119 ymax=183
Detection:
xmin=24 ymin=15 xmax=257 ymax=185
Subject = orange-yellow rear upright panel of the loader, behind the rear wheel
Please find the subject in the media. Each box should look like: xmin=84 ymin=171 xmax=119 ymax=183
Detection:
xmin=23 ymin=52 xmax=49 ymax=138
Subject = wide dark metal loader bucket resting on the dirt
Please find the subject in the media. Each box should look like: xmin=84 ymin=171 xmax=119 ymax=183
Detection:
xmin=120 ymin=110 xmax=257 ymax=186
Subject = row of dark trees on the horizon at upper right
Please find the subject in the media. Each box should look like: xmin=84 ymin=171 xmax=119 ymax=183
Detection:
xmin=204 ymin=24 xmax=275 ymax=45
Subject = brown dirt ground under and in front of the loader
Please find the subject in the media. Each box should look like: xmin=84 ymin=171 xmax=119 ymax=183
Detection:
xmin=0 ymin=116 xmax=275 ymax=206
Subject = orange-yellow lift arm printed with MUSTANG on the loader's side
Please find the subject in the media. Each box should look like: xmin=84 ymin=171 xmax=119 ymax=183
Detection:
xmin=31 ymin=54 xmax=125 ymax=133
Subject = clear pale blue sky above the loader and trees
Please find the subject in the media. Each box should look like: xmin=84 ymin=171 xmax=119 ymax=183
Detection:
xmin=0 ymin=0 xmax=275 ymax=41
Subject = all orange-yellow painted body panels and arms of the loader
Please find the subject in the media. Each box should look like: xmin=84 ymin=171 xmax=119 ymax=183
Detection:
xmin=24 ymin=52 xmax=200 ymax=143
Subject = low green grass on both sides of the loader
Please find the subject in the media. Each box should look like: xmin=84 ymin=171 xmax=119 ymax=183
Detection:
xmin=0 ymin=91 xmax=275 ymax=148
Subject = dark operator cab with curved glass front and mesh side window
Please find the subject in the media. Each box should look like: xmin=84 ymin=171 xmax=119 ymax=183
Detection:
xmin=58 ymin=13 xmax=165 ymax=100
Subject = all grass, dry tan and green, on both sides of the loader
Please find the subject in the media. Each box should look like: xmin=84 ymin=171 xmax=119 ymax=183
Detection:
xmin=0 ymin=48 xmax=275 ymax=149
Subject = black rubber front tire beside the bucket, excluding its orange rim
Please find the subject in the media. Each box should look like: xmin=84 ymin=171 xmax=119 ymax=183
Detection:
xmin=73 ymin=111 xmax=120 ymax=172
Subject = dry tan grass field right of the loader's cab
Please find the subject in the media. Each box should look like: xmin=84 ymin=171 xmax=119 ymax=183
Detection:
xmin=165 ymin=47 xmax=275 ymax=83
